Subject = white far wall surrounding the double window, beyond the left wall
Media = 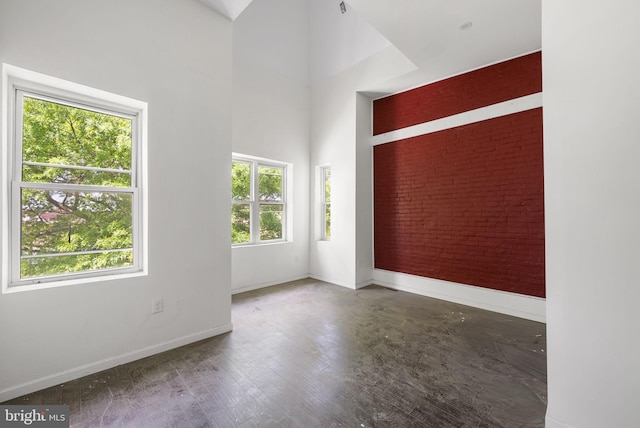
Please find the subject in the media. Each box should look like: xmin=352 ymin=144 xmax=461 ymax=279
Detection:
xmin=228 ymin=0 xmax=309 ymax=293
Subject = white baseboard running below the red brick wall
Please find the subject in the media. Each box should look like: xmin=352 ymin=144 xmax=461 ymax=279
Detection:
xmin=373 ymin=269 xmax=546 ymax=322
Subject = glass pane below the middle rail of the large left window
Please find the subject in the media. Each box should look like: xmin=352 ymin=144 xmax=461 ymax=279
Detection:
xmin=21 ymin=189 xmax=133 ymax=258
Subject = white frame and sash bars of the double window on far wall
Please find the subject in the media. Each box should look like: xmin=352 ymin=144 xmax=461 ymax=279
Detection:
xmin=231 ymin=153 xmax=292 ymax=247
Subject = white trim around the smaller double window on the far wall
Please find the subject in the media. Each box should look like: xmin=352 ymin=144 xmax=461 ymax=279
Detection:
xmin=231 ymin=152 xmax=293 ymax=248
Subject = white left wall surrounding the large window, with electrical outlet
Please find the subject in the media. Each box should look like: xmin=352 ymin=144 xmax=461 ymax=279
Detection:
xmin=0 ymin=0 xmax=232 ymax=401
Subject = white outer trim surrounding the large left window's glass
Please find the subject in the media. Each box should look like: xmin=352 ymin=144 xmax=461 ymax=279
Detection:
xmin=0 ymin=64 xmax=148 ymax=293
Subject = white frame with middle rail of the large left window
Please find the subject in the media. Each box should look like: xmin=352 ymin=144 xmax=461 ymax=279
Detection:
xmin=2 ymin=64 xmax=148 ymax=292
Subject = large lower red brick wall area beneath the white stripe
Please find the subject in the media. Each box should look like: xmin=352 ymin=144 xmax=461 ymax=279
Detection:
xmin=374 ymin=108 xmax=545 ymax=297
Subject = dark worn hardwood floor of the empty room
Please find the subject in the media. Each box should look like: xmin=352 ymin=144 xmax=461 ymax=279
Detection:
xmin=5 ymin=279 xmax=547 ymax=428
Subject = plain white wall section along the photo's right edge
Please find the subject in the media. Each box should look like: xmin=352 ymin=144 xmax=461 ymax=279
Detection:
xmin=542 ymin=0 xmax=640 ymax=428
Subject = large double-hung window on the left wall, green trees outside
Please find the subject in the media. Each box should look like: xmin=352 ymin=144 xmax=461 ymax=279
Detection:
xmin=5 ymin=64 xmax=146 ymax=285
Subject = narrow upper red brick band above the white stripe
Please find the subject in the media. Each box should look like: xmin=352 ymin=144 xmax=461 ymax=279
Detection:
xmin=373 ymin=52 xmax=542 ymax=135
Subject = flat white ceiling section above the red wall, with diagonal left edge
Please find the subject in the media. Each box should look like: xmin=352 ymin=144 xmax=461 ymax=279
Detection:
xmin=349 ymin=0 xmax=542 ymax=83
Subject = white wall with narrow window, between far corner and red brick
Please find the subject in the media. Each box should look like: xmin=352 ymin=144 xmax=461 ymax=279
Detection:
xmin=309 ymin=0 xmax=415 ymax=288
